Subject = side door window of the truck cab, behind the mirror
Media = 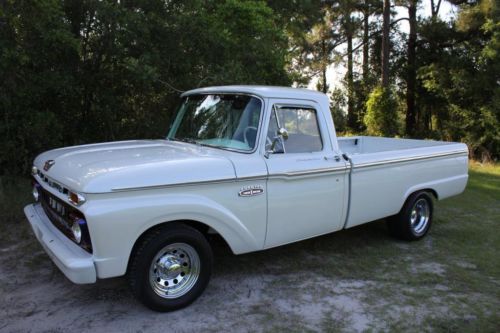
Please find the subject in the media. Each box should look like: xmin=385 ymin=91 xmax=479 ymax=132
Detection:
xmin=267 ymin=105 xmax=323 ymax=154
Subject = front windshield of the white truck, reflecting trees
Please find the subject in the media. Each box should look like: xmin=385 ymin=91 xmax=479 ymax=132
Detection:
xmin=167 ymin=94 xmax=262 ymax=151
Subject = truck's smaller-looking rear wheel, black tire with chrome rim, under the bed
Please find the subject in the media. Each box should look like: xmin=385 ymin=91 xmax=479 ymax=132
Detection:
xmin=387 ymin=192 xmax=434 ymax=241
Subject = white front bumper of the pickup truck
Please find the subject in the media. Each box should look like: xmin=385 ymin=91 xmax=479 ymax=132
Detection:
xmin=24 ymin=204 xmax=96 ymax=284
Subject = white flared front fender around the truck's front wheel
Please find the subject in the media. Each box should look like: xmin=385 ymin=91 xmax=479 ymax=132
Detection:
xmin=84 ymin=194 xmax=263 ymax=278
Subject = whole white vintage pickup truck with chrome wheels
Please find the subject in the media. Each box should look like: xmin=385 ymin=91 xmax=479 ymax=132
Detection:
xmin=24 ymin=86 xmax=468 ymax=311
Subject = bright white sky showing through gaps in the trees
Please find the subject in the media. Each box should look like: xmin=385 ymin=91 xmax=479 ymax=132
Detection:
xmin=308 ymin=0 xmax=457 ymax=90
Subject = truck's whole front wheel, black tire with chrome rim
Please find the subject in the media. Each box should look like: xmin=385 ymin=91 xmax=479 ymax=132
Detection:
xmin=127 ymin=223 xmax=213 ymax=312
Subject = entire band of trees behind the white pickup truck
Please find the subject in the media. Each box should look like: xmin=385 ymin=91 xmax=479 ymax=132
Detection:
xmin=0 ymin=0 xmax=500 ymax=174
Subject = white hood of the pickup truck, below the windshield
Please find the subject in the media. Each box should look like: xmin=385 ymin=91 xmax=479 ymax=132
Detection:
xmin=34 ymin=140 xmax=236 ymax=193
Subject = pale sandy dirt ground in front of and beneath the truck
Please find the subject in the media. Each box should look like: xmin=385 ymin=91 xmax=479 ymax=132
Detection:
xmin=0 ymin=223 xmax=498 ymax=332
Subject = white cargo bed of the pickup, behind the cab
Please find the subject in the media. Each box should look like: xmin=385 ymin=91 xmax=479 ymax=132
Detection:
xmin=338 ymin=136 xmax=468 ymax=228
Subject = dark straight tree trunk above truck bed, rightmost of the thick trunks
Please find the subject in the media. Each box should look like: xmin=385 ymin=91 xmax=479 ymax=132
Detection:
xmin=406 ymin=0 xmax=417 ymax=136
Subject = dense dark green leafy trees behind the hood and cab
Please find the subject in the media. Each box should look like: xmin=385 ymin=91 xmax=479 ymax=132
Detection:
xmin=0 ymin=0 xmax=291 ymax=175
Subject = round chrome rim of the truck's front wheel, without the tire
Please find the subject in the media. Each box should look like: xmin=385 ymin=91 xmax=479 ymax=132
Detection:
xmin=149 ymin=243 xmax=200 ymax=299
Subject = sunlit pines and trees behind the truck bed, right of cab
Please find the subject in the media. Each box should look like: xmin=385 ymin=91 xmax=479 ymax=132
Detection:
xmin=297 ymin=0 xmax=500 ymax=160
